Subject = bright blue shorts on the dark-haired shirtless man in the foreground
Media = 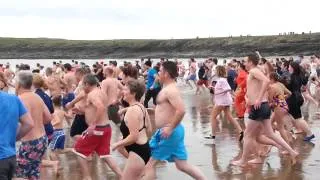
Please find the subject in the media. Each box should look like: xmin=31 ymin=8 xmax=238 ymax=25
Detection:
xmin=149 ymin=124 xmax=188 ymax=162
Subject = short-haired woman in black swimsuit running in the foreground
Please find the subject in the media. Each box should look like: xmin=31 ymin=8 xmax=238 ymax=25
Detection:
xmin=112 ymin=80 xmax=151 ymax=180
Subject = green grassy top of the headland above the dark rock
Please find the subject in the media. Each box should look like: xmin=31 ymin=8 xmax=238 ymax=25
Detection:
xmin=0 ymin=33 xmax=320 ymax=48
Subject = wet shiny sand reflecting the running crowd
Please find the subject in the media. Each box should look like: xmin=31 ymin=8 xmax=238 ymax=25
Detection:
xmin=41 ymin=88 xmax=320 ymax=180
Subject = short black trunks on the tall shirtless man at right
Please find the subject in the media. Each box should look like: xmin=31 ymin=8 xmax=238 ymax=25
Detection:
xmin=249 ymin=102 xmax=271 ymax=121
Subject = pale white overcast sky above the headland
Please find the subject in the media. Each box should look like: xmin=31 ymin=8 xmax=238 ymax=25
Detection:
xmin=0 ymin=0 xmax=320 ymax=40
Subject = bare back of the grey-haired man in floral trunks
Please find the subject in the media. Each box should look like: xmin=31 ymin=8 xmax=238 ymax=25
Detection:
xmin=19 ymin=92 xmax=51 ymax=141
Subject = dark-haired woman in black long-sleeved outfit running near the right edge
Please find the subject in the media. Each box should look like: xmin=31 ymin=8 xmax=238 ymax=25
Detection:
xmin=287 ymin=62 xmax=315 ymax=141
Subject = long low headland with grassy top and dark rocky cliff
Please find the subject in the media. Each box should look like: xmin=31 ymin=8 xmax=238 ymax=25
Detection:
xmin=0 ymin=33 xmax=320 ymax=59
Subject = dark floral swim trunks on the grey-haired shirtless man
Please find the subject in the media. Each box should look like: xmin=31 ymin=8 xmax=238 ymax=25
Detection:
xmin=16 ymin=136 xmax=48 ymax=179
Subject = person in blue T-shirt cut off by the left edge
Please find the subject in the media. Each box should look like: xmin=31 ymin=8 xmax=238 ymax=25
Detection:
xmin=0 ymin=72 xmax=34 ymax=180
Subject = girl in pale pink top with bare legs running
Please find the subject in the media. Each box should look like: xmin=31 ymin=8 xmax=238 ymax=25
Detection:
xmin=205 ymin=66 xmax=243 ymax=144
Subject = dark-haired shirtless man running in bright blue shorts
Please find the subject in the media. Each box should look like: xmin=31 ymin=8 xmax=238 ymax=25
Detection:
xmin=144 ymin=61 xmax=206 ymax=180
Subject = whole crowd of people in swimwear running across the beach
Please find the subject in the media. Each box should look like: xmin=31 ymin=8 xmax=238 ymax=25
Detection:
xmin=0 ymin=52 xmax=320 ymax=180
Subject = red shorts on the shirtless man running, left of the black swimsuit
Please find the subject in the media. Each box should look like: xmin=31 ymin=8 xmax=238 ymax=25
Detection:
xmin=74 ymin=124 xmax=111 ymax=158
